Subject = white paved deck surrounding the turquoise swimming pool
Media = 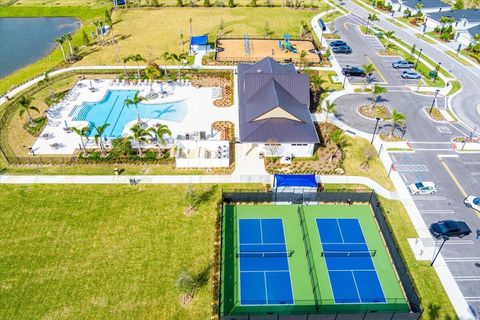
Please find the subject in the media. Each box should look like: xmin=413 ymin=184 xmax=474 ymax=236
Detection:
xmin=32 ymin=80 xmax=238 ymax=155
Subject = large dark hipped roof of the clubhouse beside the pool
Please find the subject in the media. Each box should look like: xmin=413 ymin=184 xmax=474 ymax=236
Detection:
xmin=238 ymin=58 xmax=319 ymax=143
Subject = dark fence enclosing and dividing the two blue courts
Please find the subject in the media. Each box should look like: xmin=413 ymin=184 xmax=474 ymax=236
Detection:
xmin=217 ymin=189 xmax=423 ymax=320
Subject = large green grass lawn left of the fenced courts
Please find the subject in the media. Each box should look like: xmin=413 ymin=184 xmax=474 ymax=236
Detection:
xmin=0 ymin=185 xmax=258 ymax=320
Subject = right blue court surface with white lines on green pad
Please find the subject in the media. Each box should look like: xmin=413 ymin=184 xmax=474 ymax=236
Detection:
xmin=317 ymin=219 xmax=386 ymax=303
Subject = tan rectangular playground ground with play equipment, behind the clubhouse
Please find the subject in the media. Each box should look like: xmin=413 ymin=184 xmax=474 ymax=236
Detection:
xmin=215 ymin=34 xmax=321 ymax=65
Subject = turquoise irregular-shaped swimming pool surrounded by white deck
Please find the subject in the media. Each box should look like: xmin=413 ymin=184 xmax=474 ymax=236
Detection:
xmin=72 ymin=90 xmax=188 ymax=137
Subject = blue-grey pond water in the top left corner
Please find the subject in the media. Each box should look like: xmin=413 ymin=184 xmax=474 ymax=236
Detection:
xmin=0 ymin=18 xmax=80 ymax=79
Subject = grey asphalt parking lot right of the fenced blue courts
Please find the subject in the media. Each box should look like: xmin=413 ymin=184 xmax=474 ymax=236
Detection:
xmin=392 ymin=151 xmax=480 ymax=309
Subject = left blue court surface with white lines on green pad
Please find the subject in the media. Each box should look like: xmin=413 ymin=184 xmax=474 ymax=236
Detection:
xmin=238 ymin=219 xmax=293 ymax=305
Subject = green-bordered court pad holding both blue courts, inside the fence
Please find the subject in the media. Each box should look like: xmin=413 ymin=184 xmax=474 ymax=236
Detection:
xmin=221 ymin=204 xmax=409 ymax=315
